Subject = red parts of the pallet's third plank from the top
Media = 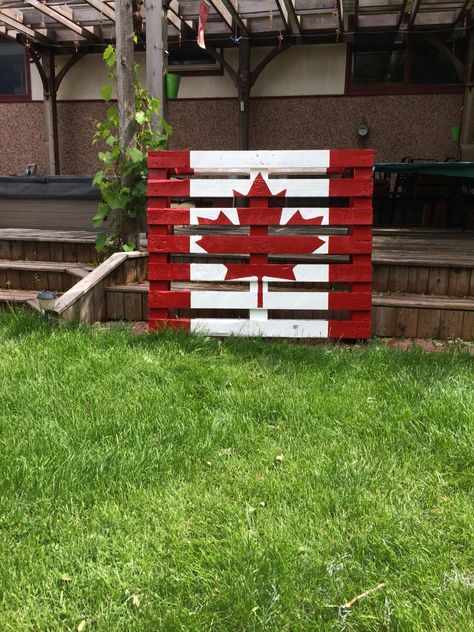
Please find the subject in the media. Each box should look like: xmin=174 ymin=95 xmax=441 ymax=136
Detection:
xmin=148 ymin=206 xmax=372 ymax=226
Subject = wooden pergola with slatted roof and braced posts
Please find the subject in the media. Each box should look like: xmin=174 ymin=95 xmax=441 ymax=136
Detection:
xmin=0 ymin=0 xmax=474 ymax=174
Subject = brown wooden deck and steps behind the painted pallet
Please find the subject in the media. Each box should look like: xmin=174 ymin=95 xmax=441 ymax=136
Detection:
xmin=0 ymin=227 xmax=474 ymax=340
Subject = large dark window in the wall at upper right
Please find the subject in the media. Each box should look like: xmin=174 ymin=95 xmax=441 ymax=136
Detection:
xmin=350 ymin=39 xmax=464 ymax=92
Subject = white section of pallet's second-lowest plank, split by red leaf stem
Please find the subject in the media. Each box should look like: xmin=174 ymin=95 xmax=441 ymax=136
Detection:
xmin=191 ymin=289 xmax=329 ymax=312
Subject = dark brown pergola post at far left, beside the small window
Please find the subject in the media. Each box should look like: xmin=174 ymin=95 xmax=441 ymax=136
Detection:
xmin=42 ymin=50 xmax=60 ymax=176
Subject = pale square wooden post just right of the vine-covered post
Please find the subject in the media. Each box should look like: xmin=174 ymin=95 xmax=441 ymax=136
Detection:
xmin=145 ymin=0 xmax=168 ymax=126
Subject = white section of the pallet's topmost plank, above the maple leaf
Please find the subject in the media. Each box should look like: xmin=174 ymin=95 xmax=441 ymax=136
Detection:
xmin=190 ymin=149 xmax=330 ymax=170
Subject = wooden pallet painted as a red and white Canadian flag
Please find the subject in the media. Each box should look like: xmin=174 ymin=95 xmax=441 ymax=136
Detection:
xmin=148 ymin=150 xmax=373 ymax=338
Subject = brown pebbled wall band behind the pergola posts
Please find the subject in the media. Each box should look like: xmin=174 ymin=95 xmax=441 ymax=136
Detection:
xmin=0 ymin=94 xmax=462 ymax=175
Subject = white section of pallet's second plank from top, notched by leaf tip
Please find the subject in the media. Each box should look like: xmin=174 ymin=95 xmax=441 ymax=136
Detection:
xmin=189 ymin=178 xmax=329 ymax=198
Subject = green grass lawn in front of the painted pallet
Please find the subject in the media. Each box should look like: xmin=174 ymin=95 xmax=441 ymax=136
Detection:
xmin=0 ymin=312 xmax=474 ymax=632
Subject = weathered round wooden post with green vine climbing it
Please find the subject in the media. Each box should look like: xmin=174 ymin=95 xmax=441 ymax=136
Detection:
xmin=115 ymin=0 xmax=139 ymax=247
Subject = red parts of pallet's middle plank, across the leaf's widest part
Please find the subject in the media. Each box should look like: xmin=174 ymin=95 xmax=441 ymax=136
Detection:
xmin=148 ymin=235 xmax=372 ymax=255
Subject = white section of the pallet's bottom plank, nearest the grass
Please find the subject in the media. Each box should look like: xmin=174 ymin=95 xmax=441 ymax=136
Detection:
xmin=191 ymin=318 xmax=329 ymax=338
